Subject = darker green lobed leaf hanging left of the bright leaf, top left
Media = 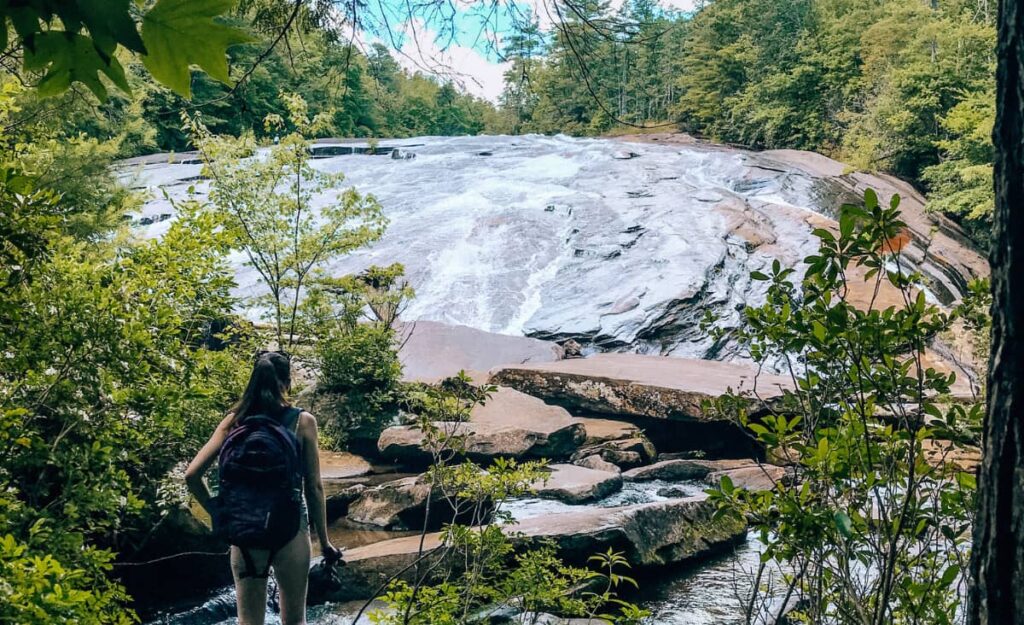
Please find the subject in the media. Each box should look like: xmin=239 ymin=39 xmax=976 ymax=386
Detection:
xmin=25 ymin=31 xmax=131 ymax=99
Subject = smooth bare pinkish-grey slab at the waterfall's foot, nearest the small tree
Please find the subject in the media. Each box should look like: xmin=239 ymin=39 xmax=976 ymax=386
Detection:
xmin=398 ymin=321 xmax=562 ymax=382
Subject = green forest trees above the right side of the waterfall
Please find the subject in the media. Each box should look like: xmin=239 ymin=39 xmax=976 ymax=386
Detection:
xmin=501 ymin=0 xmax=996 ymax=246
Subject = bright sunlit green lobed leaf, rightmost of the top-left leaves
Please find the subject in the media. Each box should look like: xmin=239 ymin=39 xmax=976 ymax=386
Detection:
xmin=142 ymin=0 xmax=252 ymax=97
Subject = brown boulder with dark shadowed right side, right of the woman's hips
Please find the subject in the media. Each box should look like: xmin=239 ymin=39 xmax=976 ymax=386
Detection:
xmin=347 ymin=475 xmax=487 ymax=531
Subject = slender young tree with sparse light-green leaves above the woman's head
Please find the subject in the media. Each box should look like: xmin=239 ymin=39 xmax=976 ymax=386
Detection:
xmin=187 ymin=94 xmax=387 ymax=347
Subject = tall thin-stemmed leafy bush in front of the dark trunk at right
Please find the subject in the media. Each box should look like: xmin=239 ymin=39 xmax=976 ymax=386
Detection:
xmin=710 ymin=191 xmax=983 ymax=625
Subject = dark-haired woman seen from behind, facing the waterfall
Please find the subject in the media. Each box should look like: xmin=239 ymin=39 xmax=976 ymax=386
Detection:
xmin=185 ymin=351 xmax=340 ymax=625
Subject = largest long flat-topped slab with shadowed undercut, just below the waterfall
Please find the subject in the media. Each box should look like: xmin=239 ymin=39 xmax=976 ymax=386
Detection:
xmin=490 ymin=353 xmax=792 ymax=421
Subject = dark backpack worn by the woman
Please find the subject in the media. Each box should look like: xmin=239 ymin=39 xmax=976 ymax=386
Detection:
xmin=214 ymin=408 xmax=302 ymax=577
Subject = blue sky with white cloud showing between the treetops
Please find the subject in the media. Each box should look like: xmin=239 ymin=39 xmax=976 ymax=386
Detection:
xmin=357 ymin=0 xmax=694 ymax=102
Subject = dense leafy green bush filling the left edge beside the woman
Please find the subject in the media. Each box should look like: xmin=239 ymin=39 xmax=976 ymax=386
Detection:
xmin=0 ymin=162 xmax=251 ymax=624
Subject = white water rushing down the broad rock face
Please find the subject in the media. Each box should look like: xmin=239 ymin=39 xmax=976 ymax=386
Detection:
xmin=123 ymin=136 xmax=830 ymax=359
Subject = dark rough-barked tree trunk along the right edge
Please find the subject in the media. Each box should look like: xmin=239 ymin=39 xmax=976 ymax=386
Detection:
xmin=969 ymin=0 xmax=1024 ymax=625
